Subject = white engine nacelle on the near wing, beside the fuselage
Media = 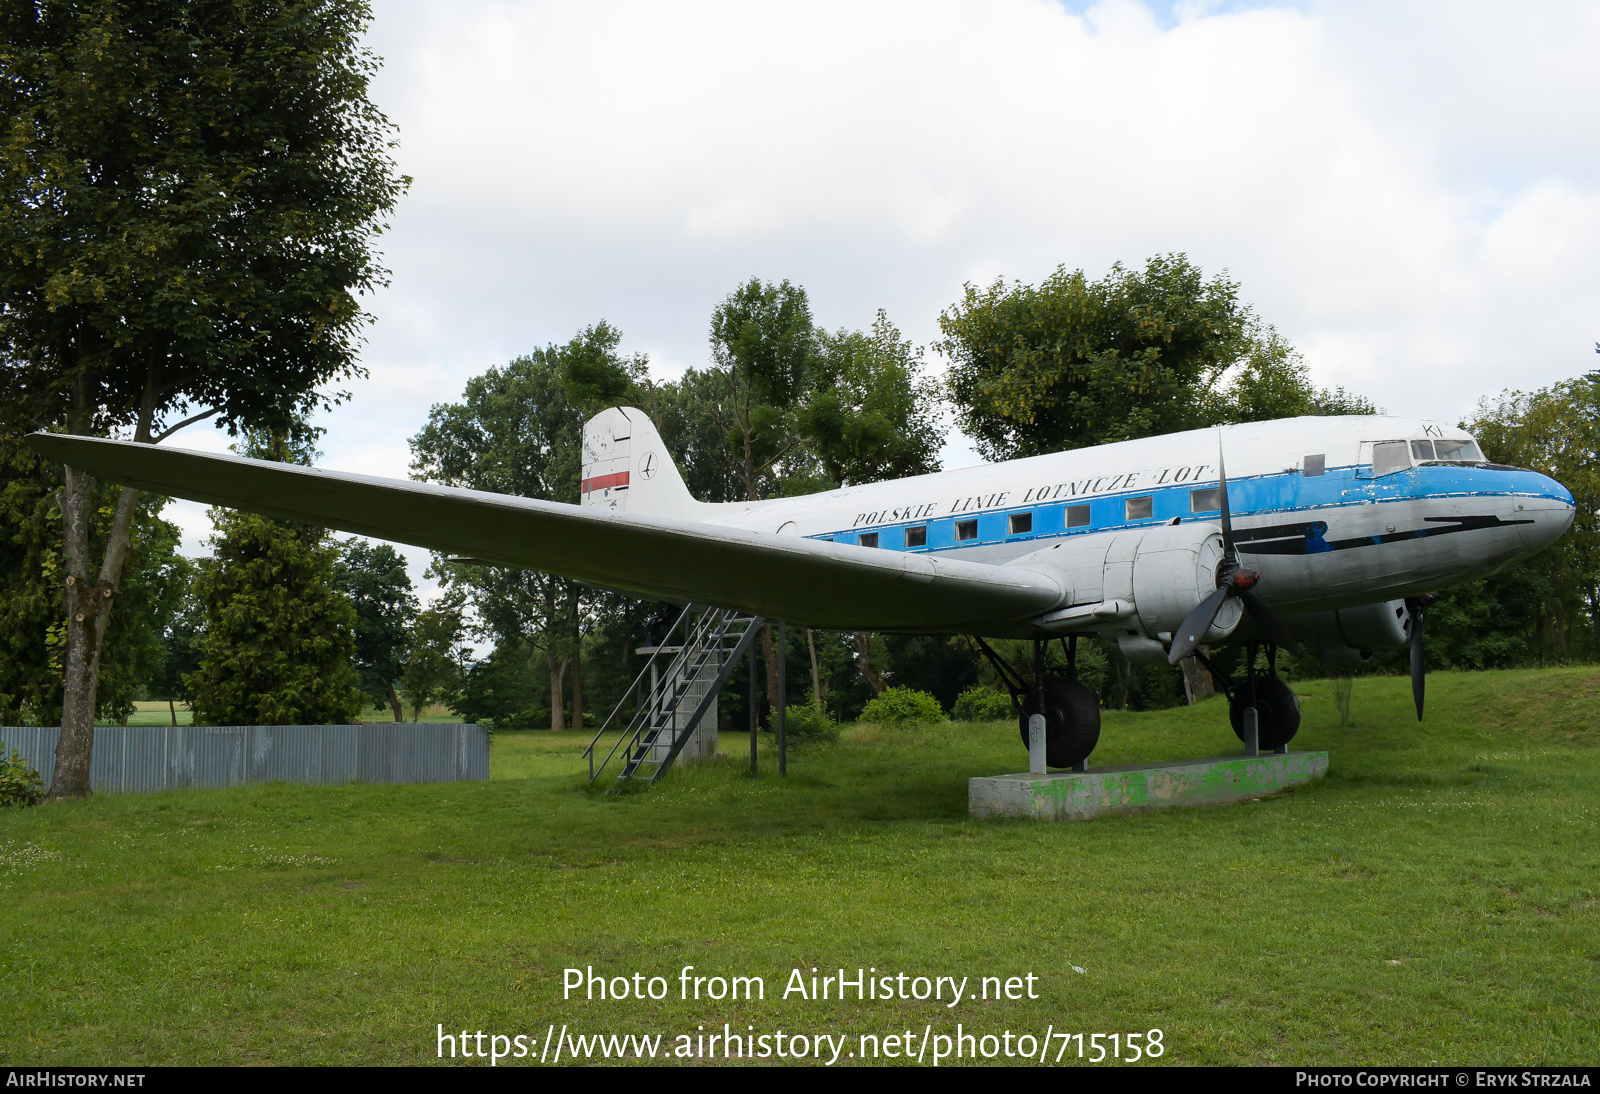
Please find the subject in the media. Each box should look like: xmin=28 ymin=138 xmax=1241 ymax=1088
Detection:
xmin=1013 ymin=521 xmax=1243 ymax=649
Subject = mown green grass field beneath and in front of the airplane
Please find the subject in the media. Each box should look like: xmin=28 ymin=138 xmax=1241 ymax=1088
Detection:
xmin=0 ymin=669 xmax=1600 ymax=1064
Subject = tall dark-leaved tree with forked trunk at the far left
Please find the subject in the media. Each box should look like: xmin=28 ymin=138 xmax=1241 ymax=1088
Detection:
xmin=0 ymin=0 xmax=406 ymax=798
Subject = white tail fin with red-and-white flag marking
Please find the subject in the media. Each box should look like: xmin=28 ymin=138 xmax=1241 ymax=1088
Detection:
xmin=579 ymin=406 xmax=699 ymax=517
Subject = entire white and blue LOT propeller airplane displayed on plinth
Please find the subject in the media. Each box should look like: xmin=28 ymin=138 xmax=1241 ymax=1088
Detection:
xmin=29 ymin=406 xmax=1574 ymax=766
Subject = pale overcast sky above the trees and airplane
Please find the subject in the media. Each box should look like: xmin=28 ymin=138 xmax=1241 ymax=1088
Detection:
xmin=159 ymin=0 xmax=1600 ymax=594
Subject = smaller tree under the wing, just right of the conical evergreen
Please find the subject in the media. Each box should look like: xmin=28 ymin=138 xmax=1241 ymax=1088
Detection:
xmin=333 ymin=537 xmax=418 ymax=721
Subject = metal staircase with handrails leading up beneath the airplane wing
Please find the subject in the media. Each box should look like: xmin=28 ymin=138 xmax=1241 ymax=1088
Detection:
xmin=584 ymin=605 xmax=765 ymax=792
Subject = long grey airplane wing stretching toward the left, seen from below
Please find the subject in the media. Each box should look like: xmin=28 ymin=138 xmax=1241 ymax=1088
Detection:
xmin=27 ymin=433 xmax=1067 ymax=633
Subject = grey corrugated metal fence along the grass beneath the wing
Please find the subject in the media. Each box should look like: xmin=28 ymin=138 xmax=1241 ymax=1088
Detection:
xmin=0 ymin=723 xmax=490 ymax=793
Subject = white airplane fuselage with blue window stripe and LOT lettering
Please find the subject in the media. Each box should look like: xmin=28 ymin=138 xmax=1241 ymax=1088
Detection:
xmin=620 ymin=416 xmax=1574 ymax=646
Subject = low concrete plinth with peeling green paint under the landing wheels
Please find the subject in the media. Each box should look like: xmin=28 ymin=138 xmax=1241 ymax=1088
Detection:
xmin=966 ymin=752 xmax=1328 ymax=821
